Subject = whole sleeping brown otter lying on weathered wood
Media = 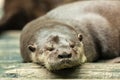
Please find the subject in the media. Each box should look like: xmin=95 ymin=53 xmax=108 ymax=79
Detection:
xmin=20 ymin=0 xmax=120 ymax=70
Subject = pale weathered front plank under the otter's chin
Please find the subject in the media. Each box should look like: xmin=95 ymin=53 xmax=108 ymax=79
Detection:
xmin=0 ymin=63 xmax=120 ymax=79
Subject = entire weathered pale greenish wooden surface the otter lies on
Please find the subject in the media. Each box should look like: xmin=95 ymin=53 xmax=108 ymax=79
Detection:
xmin=0 ymin=31 xmax=120 ymax=80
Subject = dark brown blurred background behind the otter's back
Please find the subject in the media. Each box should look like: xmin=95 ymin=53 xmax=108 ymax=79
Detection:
xmin=0 ymin=0 xmax=78 ymax=33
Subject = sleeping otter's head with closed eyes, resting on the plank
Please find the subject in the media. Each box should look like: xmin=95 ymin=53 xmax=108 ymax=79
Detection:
xmin=28 ymin=22 xmax=86 ymax=70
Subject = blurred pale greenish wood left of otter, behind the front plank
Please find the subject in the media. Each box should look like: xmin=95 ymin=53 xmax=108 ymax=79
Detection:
xmin=0 ymin=31 xmax=22 ymax=63
